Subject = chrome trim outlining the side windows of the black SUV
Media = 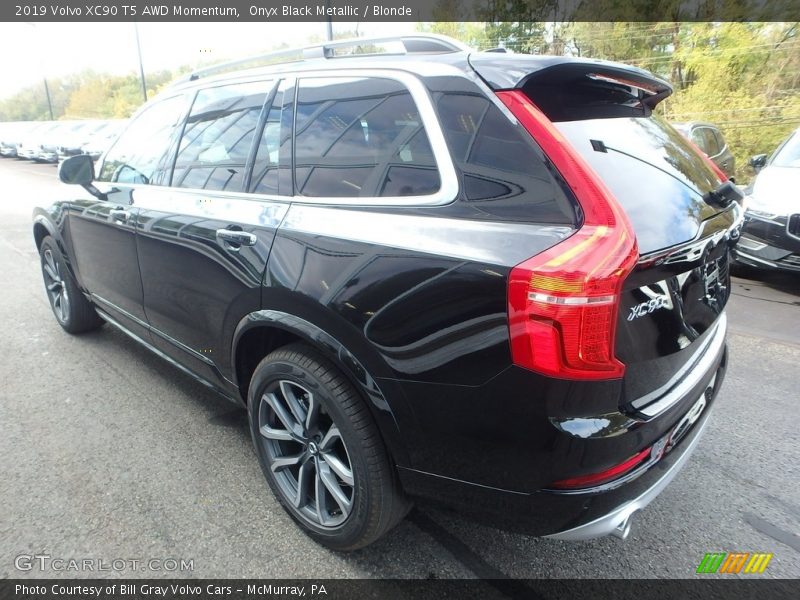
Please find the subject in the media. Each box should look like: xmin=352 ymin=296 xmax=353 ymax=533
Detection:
xmin=105 ymin=69 xmax=456 ymax=208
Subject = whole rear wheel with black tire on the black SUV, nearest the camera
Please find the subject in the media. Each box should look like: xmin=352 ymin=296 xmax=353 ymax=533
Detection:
xmin=248 ymin=343 xmax=410 ymax=550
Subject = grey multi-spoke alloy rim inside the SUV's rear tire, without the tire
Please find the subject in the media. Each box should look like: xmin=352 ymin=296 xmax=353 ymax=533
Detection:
xmin=258 ymin=379 xmax=355 ymax=528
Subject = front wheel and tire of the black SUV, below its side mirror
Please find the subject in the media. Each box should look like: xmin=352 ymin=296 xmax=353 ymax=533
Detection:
xmin=39 ymin=236 xmax=104 ymax=334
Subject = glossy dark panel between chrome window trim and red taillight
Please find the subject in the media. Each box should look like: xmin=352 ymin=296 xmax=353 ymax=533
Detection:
xmin=437 ymin=93 xmax=575 ymax=224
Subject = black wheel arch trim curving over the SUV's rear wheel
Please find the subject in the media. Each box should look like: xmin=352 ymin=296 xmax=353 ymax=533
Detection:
xmin=231 ymin=309 xmax=410 ymax=466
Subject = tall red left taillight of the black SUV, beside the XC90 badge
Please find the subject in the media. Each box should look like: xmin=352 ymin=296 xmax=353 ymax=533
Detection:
xmin=498 ymin=90 xmax=639 ymax=379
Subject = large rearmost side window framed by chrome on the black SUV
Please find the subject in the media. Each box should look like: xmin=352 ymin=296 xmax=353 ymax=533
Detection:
xmin=294 ymin=78 xmax=440 ymax=197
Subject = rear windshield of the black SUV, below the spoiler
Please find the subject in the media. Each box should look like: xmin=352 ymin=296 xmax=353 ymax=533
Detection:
xmin=555 ymin=115 xmax=719 ymax=252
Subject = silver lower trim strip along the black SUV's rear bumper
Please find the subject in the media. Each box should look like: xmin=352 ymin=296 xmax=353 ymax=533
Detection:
xmin=546 ymin=406 xmax=708 ymax=542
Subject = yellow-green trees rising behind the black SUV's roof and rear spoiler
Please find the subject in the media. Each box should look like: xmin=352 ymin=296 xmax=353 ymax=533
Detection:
xmin=420 ymin=19 xmax=800 ymax=183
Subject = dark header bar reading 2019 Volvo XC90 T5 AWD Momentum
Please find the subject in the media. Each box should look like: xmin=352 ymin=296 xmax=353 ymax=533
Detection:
xmin=0 ymin=0 xmax=800 ymax=22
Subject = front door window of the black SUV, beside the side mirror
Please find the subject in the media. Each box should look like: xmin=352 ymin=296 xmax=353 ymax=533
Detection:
xmin=98 ymin=96 xmax=187 ymax=185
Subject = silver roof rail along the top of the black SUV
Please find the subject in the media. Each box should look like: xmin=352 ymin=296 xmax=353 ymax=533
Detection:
xmin=175 ymin=33 xmax=472 ymax=83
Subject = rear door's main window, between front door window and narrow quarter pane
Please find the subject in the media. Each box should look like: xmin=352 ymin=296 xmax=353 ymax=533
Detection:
xmin=172 ymin=81 xmax=272 ymax=191
